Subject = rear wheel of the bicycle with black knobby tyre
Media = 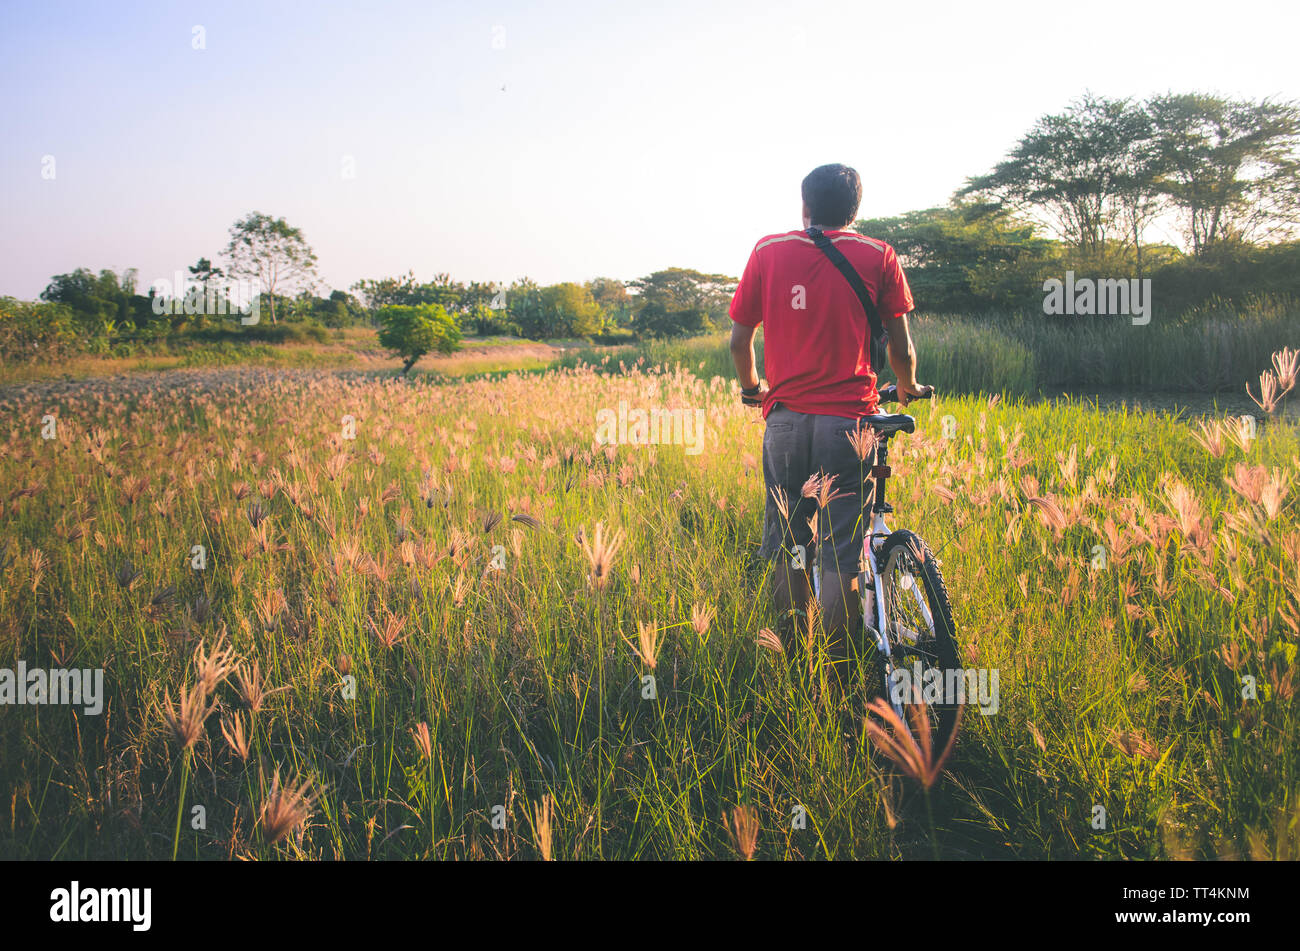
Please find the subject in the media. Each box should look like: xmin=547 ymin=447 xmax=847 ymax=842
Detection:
xmin=876 ymin=530 xmax=966 ymax=754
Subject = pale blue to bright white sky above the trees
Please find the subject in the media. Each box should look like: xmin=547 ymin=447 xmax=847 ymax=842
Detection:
xmin=0 ymin=0 xmax=1300 ymax=300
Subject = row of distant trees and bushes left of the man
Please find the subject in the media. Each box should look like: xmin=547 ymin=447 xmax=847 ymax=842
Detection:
xmin=0 ymin=202 xmax=736 ymax=369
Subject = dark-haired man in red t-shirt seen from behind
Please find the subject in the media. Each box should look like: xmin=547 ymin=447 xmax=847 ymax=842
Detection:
xmin=731 ymin=165 xmax=933 ymax=683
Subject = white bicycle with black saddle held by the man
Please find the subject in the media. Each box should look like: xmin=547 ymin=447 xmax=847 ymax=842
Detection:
xmin=813 ymin=385 xmax=961 ymax=750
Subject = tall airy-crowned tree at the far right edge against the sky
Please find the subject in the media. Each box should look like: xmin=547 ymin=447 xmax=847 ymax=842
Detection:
xmin=1148 ymin=94 xmax=1300 ymax=255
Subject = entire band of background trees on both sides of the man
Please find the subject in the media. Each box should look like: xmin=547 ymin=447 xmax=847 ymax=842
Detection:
xmin=0 ymin=94 xmax=1300 ymax=360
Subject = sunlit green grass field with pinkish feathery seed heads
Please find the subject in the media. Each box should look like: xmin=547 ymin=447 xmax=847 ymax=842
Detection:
xmin=0 ymin=342 xmax=1300 ymax=859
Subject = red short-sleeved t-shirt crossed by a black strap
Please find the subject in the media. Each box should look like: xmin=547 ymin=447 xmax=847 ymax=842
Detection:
xmin=731 ymin=230 xmax=913 ymax=420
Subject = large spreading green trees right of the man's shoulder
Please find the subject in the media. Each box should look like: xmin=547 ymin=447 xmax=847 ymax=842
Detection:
xmin=855 ymin=94 xmax=1300 ymax=313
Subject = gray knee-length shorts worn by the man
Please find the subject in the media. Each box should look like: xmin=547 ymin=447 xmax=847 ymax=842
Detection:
xmin=762 ymin=404 xmax=875 ymax=574
